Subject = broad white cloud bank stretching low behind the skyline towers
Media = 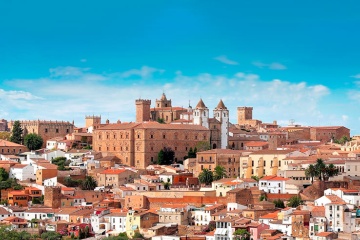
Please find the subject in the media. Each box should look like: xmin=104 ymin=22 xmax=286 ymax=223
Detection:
xmin=0 ymin=67 xmax=334 ymax=126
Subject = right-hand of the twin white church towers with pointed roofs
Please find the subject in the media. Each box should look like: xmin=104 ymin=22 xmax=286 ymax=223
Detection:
xmin=213 ymin=100 xmax=229 ymax=149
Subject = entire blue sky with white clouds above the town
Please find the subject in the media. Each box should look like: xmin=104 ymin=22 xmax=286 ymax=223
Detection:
xmin=0 ymin=0 xmax=360 ymax=135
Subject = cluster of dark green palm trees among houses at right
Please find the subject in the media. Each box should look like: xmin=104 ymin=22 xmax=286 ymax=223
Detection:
xmin=305 ymin=158 xmax=339 ymax=182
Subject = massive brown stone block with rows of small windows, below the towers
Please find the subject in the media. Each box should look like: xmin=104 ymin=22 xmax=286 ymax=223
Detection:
xmin=93 ymin=122 xmax=210 ymax=169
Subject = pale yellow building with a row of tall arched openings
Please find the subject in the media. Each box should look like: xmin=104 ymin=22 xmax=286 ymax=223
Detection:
xmin=240 ymin=150 xmax=292 ymax=178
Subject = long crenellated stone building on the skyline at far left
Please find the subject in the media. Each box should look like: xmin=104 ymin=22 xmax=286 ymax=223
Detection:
xmin=9 ymin=120 xmax=74 ymax=147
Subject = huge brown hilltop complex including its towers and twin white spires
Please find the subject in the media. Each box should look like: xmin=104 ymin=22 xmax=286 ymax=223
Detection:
xmin=93 ymin=94 xmax=229 ymax=169
